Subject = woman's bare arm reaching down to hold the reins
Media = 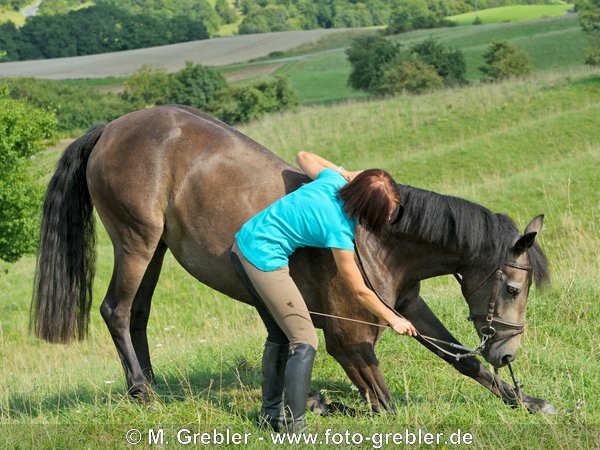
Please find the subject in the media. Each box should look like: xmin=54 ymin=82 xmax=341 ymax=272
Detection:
xmin=332 ymin=248 xmax=417 ymax=336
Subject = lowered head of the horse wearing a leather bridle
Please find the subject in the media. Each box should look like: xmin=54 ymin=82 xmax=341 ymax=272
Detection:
xmin=462 ymin=215 xmax=547 ymax=367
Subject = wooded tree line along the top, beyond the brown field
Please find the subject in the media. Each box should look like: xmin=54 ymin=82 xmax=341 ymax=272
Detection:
xmin=0 ymin=0 xmax=564 ymax=61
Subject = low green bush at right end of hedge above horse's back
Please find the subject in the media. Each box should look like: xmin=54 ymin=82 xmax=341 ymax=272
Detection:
xmin=208 ymin=77 xmax=298 ymax=124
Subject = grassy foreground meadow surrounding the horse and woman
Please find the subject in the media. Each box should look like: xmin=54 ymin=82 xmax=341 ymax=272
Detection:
xmin=0 ymin=71 xmax=600 ymax=449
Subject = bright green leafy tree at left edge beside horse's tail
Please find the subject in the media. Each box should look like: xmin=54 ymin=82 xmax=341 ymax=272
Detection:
xmin=0 ymin=91 xmax=56 ymax=262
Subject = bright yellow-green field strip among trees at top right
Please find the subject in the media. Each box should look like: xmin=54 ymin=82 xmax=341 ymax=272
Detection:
xmin=448 ymin=3 xmax=573 ymax=25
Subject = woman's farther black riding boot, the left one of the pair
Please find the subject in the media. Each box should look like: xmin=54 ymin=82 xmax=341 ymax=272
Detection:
xmin=260 ymin=341 xmax=289 ymax=431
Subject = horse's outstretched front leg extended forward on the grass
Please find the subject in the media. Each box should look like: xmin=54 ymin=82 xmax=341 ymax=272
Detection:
xmin=396 ymin=297 xmax=556 ymax=414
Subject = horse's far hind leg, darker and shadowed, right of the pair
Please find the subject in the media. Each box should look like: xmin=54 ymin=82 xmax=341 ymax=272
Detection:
xmin=129 ymin=241 xmax=167 ymax=383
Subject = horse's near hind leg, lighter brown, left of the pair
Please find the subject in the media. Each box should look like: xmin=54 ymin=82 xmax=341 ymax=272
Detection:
xmin=100 ymin=235 xmax=158 ymax=398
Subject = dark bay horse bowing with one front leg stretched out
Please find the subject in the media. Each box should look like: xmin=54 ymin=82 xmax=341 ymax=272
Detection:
xmin=31 ymin=106 xmax=554 ymax=412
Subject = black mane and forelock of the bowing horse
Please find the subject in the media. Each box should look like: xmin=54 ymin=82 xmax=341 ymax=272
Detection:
xmin=393 ymin=185 xmax=549 ymax=286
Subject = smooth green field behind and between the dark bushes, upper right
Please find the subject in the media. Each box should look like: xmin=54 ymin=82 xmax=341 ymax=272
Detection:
xmin=225 ymin=14 xmax=588 ymax=104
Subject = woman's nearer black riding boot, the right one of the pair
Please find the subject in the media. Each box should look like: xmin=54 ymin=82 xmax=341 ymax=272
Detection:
xmin=284 ymin=344 xmax=316 ymax=433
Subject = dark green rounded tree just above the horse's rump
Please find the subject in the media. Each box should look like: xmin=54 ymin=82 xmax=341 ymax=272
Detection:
xmin=167 ymin=61 xmax=226 ymax=109
